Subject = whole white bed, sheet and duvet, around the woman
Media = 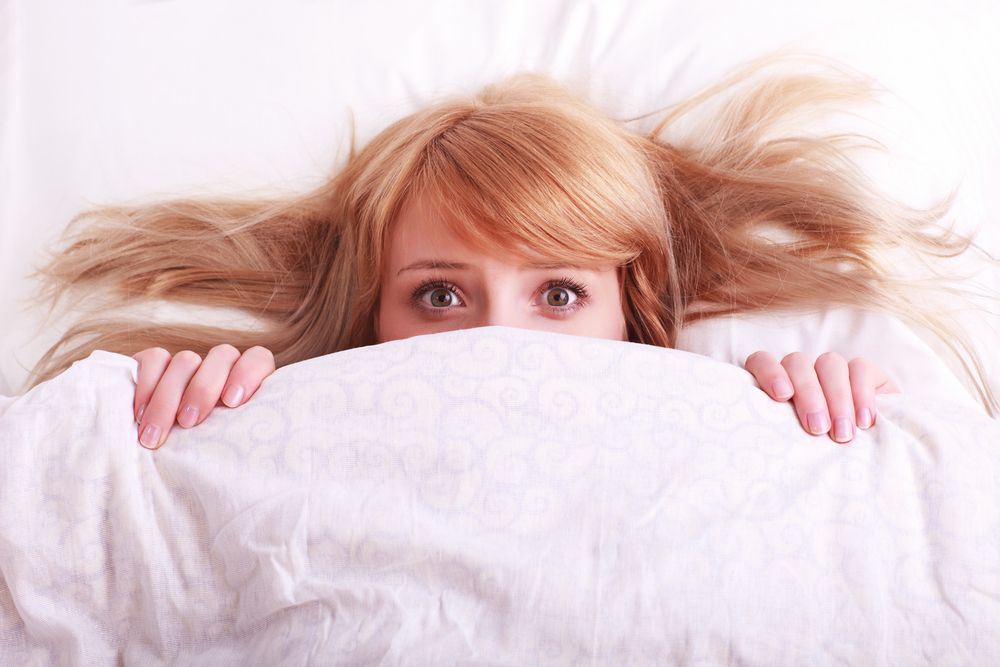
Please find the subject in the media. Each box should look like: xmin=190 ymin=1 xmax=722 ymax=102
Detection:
xmin=0 ymin=0 xmax=1000 ymax=665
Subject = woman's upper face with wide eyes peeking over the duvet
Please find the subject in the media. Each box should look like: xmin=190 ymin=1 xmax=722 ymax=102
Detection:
xmin=375 ymin=202 xmax=627 ymax=343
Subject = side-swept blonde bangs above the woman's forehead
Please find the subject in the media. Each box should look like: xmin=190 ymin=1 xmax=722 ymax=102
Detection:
xmin=410 ymin=102 xmax=659 ymax=266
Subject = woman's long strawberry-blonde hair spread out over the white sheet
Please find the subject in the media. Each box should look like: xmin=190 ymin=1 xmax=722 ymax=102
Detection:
xmin=31 ymin=54 xmax=998 ymax=413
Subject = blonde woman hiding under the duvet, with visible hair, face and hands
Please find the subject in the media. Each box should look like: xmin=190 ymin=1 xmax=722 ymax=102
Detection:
xmin=27 ymin=56 xmax=996 ymax=448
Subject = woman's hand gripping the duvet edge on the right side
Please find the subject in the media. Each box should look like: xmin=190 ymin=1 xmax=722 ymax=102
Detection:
xmin=744 ymin=352 xmax=899 ymax=442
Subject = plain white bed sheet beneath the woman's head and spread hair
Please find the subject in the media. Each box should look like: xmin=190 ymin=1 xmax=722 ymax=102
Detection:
xmin=0 ymin=0 xmax=1000 ymax=404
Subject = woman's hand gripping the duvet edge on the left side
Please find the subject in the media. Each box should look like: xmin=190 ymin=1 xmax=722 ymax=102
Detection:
xmin=132 ymin=345 xmax=274 ymax=449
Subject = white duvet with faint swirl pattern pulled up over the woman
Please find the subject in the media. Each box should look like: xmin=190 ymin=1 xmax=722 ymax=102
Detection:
xmin=0 ymin=327 xmax=1000 ymax=665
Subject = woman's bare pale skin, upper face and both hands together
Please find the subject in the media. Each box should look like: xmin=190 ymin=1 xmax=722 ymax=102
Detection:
xmin=133 ymin=202 xmax=899 ymax=449
